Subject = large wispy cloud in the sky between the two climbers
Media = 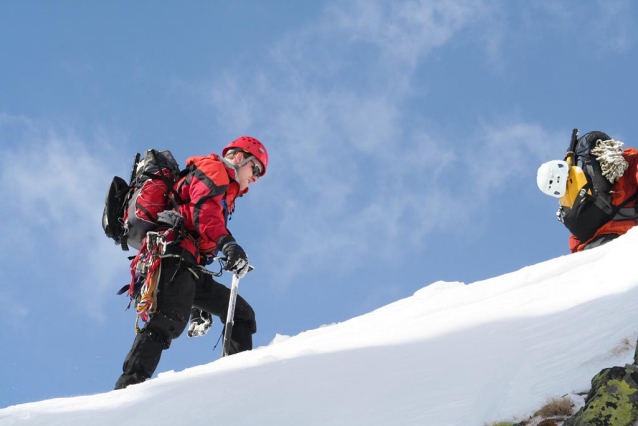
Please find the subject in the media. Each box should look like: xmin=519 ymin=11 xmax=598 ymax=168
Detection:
xmin=204 ymin=1 xmax=564 ymax=281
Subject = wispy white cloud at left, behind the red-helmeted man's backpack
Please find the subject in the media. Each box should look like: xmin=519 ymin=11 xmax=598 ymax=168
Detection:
xmin=0 ymin=114 xmax=129 ymax=317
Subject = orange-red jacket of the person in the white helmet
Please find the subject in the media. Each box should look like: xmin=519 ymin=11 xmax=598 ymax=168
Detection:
xmin=569 ymin=148 xmax=638 ymax=253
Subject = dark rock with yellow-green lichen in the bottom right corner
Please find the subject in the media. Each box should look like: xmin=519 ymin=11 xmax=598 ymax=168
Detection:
xmin=563 ymin=367 xmax=638 ymax=426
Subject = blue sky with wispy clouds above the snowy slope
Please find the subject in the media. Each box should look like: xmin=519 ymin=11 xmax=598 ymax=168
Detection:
xmin=0 ymin=0 xmax=638 ymax=407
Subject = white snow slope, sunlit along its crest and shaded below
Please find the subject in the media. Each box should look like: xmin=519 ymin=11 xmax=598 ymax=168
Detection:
xmin=0 ymin=229 xmax=638 ymax=426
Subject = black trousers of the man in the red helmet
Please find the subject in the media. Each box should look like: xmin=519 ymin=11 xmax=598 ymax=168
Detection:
xmin=115 ymin=248 xmax=257 ymax=389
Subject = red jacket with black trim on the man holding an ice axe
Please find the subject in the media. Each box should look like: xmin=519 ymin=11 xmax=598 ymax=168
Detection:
xmin=175 ymin=154 xmax=248 ymax=261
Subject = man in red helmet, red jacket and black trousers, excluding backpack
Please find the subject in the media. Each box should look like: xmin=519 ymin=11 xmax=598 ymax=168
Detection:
xmin=115 ymin=136 xmax=268 ymax=389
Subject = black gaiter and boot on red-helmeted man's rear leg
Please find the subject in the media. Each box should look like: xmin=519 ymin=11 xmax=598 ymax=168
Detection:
xmin=115 ymin=328 xmax=170 ymax=389
